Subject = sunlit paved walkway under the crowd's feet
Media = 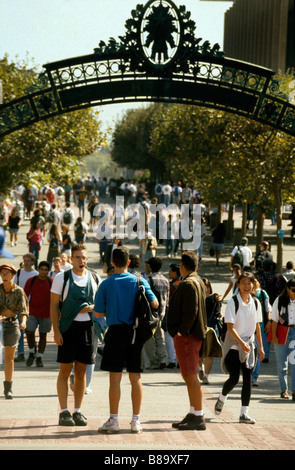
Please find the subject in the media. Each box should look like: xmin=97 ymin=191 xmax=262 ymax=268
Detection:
xmin=0 ymin=201 xmax=295 ymax=455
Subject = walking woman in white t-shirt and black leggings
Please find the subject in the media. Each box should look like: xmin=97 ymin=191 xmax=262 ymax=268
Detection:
xmin=215 ymin=272 xmax=264 ymax=424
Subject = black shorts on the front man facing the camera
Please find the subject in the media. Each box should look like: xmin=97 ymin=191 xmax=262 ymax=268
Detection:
xmin=57 ymin=321 xmax=95 ymax=364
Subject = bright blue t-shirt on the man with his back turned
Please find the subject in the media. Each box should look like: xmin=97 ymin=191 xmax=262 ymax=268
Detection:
xmin=94 ymin=273 xmax=156 ymax=326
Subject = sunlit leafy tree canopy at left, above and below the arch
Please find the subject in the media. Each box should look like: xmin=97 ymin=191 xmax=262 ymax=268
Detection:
xmin=0 ymin=55 xmax=103 ymax=193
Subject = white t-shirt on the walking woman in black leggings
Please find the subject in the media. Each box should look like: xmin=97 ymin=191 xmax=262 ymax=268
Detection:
xmin=224 ymin=294 xmax=262 ymax=349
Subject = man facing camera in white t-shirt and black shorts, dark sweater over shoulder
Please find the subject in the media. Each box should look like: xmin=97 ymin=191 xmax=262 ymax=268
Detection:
xmin=50 ymin=244 xmax=101 ymax=426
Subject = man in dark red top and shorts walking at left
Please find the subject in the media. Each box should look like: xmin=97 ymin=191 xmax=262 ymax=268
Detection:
xmin=24 ymin=261 xmax=52 ymax=367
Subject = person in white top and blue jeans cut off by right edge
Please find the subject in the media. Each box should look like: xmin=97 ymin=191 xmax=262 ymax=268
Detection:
xmin=270 ymin=277 xmax=295 ymax=401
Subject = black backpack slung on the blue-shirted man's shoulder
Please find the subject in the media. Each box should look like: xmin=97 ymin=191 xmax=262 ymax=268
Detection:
xmin=132 ymin=275 xmax=160 ymax=344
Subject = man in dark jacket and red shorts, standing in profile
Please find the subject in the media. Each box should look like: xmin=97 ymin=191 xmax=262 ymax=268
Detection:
xmin=167 ymin=251 xmax=207 ymax=431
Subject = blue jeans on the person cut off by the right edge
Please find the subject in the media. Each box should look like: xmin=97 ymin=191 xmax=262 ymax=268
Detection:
xmin=274 ymin=326 xmax=295 ymax=392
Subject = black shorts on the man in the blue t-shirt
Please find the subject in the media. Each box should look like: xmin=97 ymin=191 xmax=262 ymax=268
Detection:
xmin=101 ymin=324 xmax=143 ymax=373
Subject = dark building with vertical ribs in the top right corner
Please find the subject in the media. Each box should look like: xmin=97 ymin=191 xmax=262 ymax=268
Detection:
xmin=223 ymin=0 xmax=295 ymax=73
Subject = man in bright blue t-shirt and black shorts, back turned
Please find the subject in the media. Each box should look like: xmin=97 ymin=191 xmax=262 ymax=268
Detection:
xmin=94 ymin=246 xmax=159 ymax=434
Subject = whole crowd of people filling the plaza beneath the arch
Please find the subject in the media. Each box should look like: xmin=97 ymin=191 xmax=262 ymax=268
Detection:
xmin=0 ymin=178 xmax=295 ymax=433
